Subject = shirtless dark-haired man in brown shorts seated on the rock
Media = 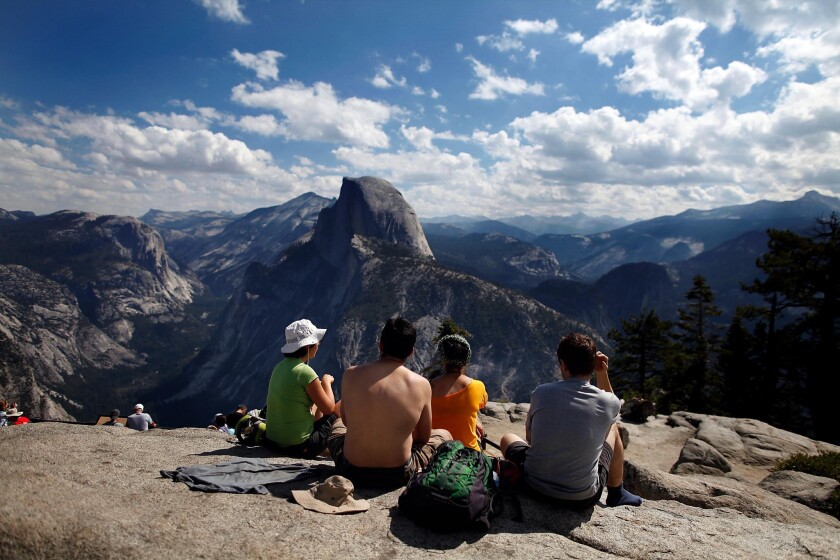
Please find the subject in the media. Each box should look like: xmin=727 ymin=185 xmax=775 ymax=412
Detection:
xmin=327 ymin=317 xmax=452 ymax=488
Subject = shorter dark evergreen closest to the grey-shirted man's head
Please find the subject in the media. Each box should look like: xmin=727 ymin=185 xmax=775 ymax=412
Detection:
xmin=608 ymin=309 xmax=671 ymax=400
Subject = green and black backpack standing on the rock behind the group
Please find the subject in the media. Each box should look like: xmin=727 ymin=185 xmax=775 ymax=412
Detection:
xmin=399 ymin=440 xmax=497 ymax=531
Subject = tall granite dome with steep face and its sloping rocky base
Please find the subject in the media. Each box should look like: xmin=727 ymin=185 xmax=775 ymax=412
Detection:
xmin=169 ymin=177 xmax=586 ymax=424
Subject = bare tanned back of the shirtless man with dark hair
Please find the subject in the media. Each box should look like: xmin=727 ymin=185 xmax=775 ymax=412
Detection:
xmin=341 ymin=357 xmax=432 ymax=468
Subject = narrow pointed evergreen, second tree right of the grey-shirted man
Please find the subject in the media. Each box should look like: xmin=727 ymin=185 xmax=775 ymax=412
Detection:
xmin=663 ymin=274 xmax=721 ymax=412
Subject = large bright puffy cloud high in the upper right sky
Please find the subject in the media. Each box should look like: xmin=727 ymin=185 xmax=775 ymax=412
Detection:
xmin=582 ymin=18 xmax=767 ymax=111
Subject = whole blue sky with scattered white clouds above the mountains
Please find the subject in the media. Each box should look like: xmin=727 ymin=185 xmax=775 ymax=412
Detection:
xmin=0 ymin=0 xmax=840 ymax=219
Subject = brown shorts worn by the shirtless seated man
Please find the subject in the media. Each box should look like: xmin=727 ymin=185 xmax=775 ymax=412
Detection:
xmin=327 ymin=418 xmax=446 ymax=488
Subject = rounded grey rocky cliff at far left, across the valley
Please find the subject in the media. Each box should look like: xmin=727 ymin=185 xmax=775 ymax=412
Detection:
xmin=0 ymin=211 xmax=203 ymax=418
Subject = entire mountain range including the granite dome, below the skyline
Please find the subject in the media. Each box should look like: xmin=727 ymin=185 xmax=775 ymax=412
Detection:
xmin=0 ymin=184 xmax=840 ymax=425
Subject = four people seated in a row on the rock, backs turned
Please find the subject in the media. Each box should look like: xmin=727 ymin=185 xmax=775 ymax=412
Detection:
xmin=266 ymin=317 xmax=642 ymax=508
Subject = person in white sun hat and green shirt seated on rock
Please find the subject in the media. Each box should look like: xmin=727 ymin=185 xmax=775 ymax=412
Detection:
xmin=265 ymin=319 xmax=338 ymax=459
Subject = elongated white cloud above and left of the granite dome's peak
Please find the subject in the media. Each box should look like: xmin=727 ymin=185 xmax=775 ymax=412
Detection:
xmin=231 ymin=81 xmax=400 ymax=148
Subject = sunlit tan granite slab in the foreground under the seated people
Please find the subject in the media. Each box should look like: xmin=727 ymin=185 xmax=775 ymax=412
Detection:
xmin=0 ymin=411 xmax=840 ymax=560
